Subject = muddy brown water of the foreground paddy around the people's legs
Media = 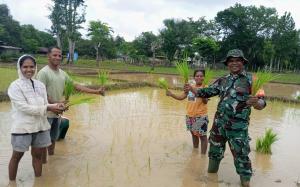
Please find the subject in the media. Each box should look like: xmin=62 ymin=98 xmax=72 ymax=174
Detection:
xmin=0 ymin=88 xmax=300 ymax=187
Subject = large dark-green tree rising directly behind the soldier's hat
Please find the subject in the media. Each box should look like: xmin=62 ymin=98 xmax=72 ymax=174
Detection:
xmin=215 ymin=4 xmax=277 ymax=69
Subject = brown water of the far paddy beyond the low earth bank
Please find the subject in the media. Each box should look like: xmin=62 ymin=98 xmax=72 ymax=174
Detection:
xmin=111 ymin=73 xmax=300 ymax=99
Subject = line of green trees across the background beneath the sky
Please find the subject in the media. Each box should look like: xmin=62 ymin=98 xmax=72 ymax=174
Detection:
xmin=0 ymin=0 xmax=300 ymax=71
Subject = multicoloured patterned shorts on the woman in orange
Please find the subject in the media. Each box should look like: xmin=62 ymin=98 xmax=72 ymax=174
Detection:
xmin=186 ymin=116 xmax=208 ymax=137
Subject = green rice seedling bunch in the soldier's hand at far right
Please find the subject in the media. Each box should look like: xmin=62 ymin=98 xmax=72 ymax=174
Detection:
xmin=251 ymin=71 xmax=278 ymax=95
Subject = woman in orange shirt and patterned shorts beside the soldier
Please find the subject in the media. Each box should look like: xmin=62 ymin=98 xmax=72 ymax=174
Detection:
xmin=166 ymin=70 xmax=208 ymax=154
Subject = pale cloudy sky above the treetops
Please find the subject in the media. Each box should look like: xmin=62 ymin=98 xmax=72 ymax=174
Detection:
xmin=0 ymin=0 xmax=300 ymax=41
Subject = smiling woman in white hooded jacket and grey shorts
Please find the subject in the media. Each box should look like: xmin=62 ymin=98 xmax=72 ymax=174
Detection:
xmin=8 ymin=55 xmax=64 ymax=180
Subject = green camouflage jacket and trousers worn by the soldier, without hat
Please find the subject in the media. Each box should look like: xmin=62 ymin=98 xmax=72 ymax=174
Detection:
xmin=197 ymin=71 xmax=264 ymax=179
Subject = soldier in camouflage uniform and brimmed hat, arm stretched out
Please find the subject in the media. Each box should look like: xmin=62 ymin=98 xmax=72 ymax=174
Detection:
xmin=184 ymin=49 xmax=266 ymax=186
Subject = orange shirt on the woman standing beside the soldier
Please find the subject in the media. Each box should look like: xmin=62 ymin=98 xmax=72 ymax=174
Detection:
xmin=186 ymin=85 xmax=207 ymax=117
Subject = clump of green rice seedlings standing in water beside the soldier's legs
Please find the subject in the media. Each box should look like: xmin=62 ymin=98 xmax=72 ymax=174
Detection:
xmin=256 ymin=129 xmax=278 ymax=154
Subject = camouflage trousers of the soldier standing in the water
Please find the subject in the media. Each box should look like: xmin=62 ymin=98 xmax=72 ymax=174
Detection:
xmin=208 ymin=118 xmax=252 ymax=179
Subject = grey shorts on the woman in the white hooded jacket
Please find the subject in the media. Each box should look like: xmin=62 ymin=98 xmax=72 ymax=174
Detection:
xmin=11 ymin=130 xmax=51 ymax=152
